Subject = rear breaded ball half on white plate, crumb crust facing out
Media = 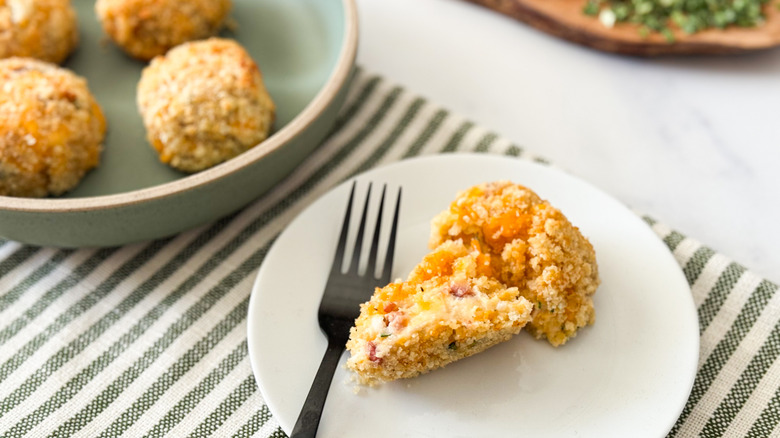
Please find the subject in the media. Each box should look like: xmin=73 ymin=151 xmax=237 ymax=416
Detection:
xmin=430 ymin=181 xmax=599 ymax=346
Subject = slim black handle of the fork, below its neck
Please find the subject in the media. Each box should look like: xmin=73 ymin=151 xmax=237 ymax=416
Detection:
xmin=290 ymin=342 xmax=345 ymax=438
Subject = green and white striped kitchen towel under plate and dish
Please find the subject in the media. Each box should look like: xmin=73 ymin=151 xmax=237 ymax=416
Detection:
xmin=0 ymin=72 xmax=780 ymax=438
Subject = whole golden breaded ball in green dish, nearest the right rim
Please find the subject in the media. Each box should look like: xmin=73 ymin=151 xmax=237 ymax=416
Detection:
xmin=138 ymin=38 xmax=275 ymax=172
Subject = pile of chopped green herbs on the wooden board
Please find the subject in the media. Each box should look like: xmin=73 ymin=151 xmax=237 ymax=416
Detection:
xmin=582 ymin=0 xmax=768 ymax=39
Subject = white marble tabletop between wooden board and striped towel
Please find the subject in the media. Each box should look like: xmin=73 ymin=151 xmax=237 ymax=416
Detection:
xmin=357 ymin=0 xmax=780 ymax=282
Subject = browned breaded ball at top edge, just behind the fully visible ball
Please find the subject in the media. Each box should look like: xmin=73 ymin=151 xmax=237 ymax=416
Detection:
xmin=95 ymin=0 xmax=231 ymax=60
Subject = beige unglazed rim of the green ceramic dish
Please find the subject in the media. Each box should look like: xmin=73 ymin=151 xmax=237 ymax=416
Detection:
xmin=0 ymin=0 xmax=358 ymax=213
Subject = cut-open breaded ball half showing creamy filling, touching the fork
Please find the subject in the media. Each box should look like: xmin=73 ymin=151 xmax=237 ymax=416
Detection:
xmin=347 ymin=241 xmax=533 ymax=385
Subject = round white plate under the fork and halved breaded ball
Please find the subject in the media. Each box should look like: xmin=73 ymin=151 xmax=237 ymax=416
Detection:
xmin=248 ymin=154 xmax=699 ymax=438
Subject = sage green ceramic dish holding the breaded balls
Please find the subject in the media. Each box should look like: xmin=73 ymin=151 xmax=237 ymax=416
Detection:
xmin=0 ymin=0 xmax=358 ymax=247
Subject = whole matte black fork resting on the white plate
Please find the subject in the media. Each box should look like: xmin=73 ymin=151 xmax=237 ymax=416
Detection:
xmin=290 ymin=183 xmax=401 ymax=438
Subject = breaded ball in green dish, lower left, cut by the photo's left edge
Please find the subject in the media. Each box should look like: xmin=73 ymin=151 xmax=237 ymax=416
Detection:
xmin=0 ymin=58 xmax=106 ymax=197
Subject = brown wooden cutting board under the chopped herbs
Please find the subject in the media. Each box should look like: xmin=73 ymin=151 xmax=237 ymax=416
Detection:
xmin=467 ymin=0 xmax=780 ymax=56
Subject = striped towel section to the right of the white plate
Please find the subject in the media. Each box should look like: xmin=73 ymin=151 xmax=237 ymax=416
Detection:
xmin=653 ymin=224 xmax=780 ymax=437
